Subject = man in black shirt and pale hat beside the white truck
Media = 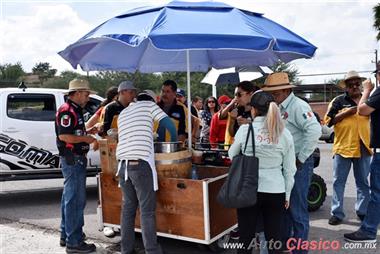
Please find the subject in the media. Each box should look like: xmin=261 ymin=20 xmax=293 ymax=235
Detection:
xmin=55 ymin=79 xmax=96 ymax=253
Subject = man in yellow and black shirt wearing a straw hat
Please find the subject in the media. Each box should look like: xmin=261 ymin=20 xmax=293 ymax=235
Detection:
xmin=325 ymin=71 xmax=372 ymax=225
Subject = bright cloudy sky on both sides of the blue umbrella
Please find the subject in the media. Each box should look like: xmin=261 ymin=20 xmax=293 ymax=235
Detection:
xmin=0 ymin=0 xmax=380 ymax=84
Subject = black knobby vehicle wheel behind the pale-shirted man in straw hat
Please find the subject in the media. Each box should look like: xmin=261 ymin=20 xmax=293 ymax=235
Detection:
xmin=307 ymin=174 xmax=327 ymax=212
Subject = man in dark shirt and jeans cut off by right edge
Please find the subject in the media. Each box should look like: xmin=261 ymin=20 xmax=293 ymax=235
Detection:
xmin=344 ymin=62 xmax=380 ymax=242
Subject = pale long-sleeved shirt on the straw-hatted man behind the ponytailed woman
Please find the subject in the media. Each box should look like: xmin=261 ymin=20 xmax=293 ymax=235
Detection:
xmin=280 ymin=93 xmax=322 ymax=163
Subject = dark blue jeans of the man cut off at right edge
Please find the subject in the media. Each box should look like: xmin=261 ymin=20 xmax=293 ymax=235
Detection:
xmin=360 ymin=153 xmax=380 ymax=238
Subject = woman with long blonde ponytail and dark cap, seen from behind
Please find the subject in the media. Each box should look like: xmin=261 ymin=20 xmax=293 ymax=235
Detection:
xmin=228 ymin=90 xmax=296 ymax=253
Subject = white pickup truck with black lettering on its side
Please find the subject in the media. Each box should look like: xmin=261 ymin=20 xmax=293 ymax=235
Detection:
xmin=0 ymin=88 xmax=103 ymax=181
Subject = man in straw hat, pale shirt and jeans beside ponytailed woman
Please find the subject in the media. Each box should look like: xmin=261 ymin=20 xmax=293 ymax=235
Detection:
xmin=262 ymin=72 xmax=321 ymax=253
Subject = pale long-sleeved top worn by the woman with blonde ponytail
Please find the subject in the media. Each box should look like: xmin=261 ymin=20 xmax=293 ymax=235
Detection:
xmin=228 ymin=116 xmax=297 ymax=201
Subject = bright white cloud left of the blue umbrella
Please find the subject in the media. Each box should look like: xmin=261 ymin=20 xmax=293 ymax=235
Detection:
xmin=0 ymin=4 xmax=91 ymax=71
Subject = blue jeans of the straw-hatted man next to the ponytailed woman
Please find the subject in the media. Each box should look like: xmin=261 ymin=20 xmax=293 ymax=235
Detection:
xmin=284 ymin=155 xmax=314 ymax=253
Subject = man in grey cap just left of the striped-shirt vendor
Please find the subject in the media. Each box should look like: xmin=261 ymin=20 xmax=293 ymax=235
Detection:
xmin=103 ymin=81 xmax=136 ymax=136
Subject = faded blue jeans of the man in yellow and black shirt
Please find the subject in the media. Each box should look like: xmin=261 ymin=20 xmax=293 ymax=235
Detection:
xmin=331 ymin=151 xmax=371 ymax=220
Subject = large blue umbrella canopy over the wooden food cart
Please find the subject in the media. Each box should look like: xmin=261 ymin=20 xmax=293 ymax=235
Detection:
xmin=59 ymin=1 xmax=316 ymax=73
